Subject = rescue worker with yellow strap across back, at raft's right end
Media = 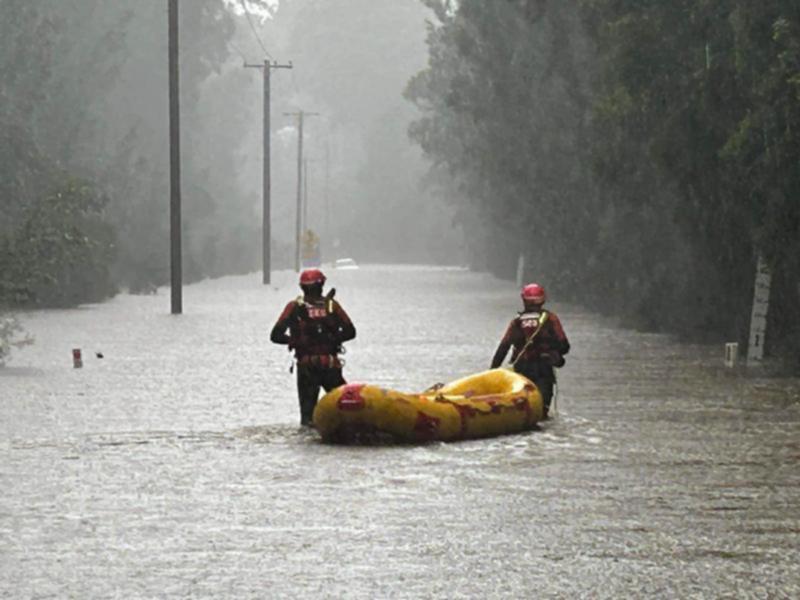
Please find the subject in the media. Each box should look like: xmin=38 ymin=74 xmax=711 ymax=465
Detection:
xmin=492 ymin=283 xmax=569 ymax=418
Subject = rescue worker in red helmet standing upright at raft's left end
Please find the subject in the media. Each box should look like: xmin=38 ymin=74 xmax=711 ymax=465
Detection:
xmin=270 ymin=269 xmax=356 ymax=425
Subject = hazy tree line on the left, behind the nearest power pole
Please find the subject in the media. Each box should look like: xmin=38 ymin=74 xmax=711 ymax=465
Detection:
xmin=0 ymin=0 xmax=274 ymax=308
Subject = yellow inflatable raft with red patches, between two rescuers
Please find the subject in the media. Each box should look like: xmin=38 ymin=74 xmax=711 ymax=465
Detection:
xmin=314 ymin=369 xmax=543 ymax=443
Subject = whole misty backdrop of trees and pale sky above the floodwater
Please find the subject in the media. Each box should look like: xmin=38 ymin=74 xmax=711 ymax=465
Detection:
xmin=0 ymin=0 xmax=800 ymax=368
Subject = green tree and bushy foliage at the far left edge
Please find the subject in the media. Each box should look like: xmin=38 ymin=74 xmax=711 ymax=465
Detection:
xmin=0 ymin=5 xmax=119 ymax=307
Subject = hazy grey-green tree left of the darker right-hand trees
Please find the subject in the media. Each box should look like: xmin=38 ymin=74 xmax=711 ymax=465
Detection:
xmin=407 ymin=0 xmax=592 ymax=286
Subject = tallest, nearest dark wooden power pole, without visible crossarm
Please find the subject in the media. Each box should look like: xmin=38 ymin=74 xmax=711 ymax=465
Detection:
xmin=168 ymin=0 xmax=183 ymax=315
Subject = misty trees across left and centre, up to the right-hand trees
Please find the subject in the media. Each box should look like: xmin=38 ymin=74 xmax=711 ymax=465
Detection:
xmin=0 ymin=0 xmax=458 ymax=308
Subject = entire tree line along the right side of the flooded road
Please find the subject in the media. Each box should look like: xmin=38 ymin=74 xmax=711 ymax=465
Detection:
xmin=406 ymin=0 xmax=800 ymax=367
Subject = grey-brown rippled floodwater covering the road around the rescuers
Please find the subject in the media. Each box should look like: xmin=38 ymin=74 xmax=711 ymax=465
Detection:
xmin=0 ymin=267 xmax=800 ymax=598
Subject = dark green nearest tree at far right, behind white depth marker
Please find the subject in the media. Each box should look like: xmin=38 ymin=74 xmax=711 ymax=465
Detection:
xmin=585 ymin=0 xmax=798 ymax=358
